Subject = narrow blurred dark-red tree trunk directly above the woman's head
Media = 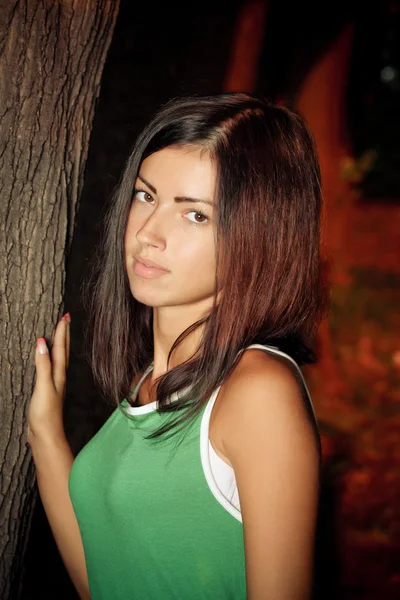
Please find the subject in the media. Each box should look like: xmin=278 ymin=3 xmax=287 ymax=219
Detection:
xmin=223 ymin=0 xmax=268 ymax=93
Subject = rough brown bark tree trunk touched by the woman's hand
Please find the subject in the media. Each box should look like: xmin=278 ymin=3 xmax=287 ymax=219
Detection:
xmin=0 ymin=0 xmax=119 ymax=599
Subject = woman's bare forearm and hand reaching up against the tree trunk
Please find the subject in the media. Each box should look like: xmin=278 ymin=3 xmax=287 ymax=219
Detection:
xmin=28 ymin=320 xmax=90 ymax=600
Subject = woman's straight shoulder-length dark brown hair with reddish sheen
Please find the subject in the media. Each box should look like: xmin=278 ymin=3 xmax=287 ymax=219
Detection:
xmin=83 ymin=93 xmax=327 ymax=437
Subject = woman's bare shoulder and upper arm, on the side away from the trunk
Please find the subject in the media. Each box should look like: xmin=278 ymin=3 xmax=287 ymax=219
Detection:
xmin=222 ymin=351 xmax=319 ymax=600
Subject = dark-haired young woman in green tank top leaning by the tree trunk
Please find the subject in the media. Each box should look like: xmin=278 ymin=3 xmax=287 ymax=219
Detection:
xmin=28 ymin=93 xmax=326 ymax=600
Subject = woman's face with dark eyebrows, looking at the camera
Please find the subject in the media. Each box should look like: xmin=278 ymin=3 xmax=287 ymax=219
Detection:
xmin=125 ymin=147 xmax=216 ymax=312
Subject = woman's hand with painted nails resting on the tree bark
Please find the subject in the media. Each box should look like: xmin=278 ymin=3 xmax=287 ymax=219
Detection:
xmin=28 ymin=313 xmax=71 ymax=444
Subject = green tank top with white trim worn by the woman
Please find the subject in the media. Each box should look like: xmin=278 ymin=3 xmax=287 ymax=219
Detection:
xmin=69 ymin=345 xmax=318 ymax=600
